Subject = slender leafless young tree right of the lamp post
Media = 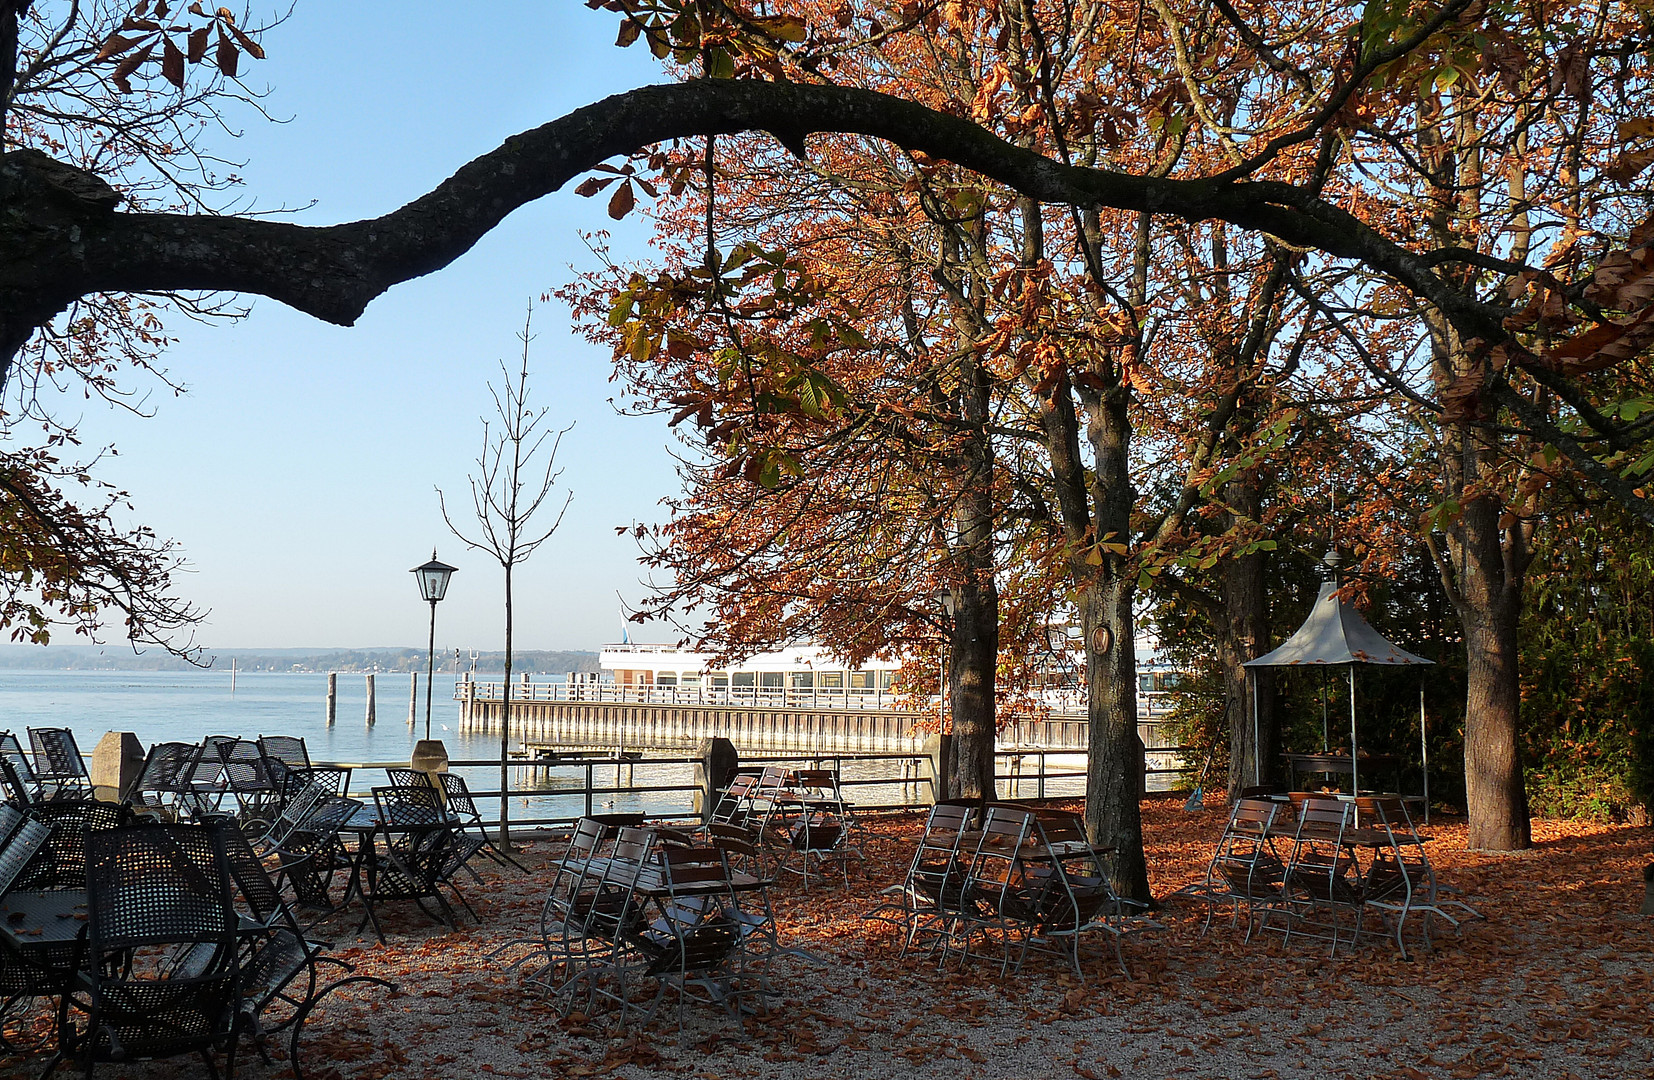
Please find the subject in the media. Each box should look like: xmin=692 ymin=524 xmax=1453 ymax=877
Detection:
xmin=437 ymin=303 xmax=574 ymax=850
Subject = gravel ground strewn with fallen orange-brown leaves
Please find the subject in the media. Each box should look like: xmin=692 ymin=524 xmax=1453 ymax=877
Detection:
xmin=0 ymin=799 xmax=1654 ymax=1080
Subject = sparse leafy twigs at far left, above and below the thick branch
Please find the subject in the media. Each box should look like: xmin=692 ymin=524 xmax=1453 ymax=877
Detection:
xmin=0 ymin=0 xmax=263 ymax=657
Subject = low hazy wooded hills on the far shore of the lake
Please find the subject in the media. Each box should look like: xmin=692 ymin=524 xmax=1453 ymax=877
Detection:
xmin=0 ymin=645 xmax=599 ymax=675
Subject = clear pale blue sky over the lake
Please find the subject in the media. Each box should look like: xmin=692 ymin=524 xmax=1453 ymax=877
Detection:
xmin=61 ymin=0 xmax=676 ymax=650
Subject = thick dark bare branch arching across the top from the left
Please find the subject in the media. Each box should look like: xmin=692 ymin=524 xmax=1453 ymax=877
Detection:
xmin=0 ymin=79 xmax=1505 ymax=379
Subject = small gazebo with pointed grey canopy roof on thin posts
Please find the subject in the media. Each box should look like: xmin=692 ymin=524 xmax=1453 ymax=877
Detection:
xmin=1242 ymin=551 xmax=1436 ymax=800
